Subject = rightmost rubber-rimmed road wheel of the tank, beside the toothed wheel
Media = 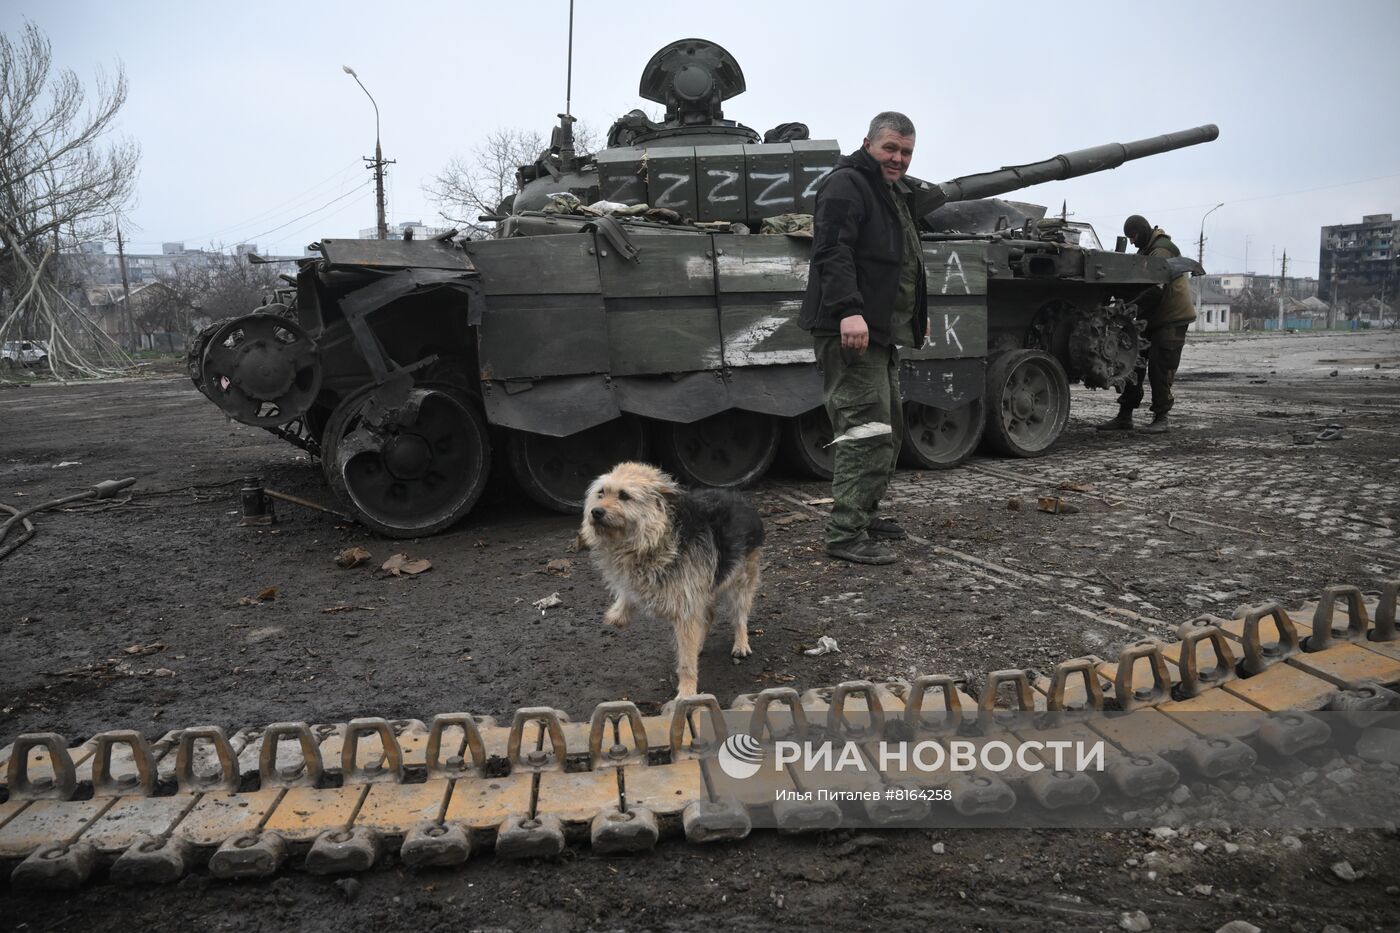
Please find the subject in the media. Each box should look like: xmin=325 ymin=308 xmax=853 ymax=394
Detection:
xmin=986 ymin=350 xmax=1070 ymax=457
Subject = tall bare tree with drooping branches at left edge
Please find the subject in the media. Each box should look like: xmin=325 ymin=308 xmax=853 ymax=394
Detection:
xmin=0 ymin=22 xmax=140 ymax=375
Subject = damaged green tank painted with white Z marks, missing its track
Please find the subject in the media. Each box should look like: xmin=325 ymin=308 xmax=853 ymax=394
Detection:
xmin=189 ymin=39 xmax=1217 ymax=537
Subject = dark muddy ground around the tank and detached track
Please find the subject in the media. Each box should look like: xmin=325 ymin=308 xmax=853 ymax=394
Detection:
xmin=0 ymin=332 xmax=1400 ymax=930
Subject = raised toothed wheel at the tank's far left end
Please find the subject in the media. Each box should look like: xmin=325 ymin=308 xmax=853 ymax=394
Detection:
xmin=198 ymin=314 xmax=321 ymax=427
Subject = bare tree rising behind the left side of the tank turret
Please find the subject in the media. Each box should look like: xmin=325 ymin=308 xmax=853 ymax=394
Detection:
xmin=423 ymin=123 xmax=598 ymax=228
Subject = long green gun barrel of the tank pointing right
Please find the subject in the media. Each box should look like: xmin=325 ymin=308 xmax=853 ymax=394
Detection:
xmin=910 ymin=123 xmax=1219 ymax=214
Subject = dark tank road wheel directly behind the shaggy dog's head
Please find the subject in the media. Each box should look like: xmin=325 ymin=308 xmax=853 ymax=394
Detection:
xmin=505 ymin=416 xmax=647 ymax=514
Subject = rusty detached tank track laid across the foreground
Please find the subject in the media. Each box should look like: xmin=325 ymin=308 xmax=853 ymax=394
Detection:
xmin=0 ymin=581 xmax=1400 ymax=888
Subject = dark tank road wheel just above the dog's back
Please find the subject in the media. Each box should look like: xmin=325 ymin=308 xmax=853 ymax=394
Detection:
xmin=657 ymin=409 xmax=778 ymax=489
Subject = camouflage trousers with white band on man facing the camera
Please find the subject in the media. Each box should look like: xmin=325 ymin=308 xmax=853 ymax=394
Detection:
xmin=813 ymin=335 xmax=904 ymax=545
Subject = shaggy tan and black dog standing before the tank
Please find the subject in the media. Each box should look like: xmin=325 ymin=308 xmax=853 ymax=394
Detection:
xmin=580 ymin=464 xmax=763 ymax=696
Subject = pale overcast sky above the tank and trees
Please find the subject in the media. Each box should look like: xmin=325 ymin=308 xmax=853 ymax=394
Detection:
xmin=10 ymin=0 xmax=1400 ymax=276
